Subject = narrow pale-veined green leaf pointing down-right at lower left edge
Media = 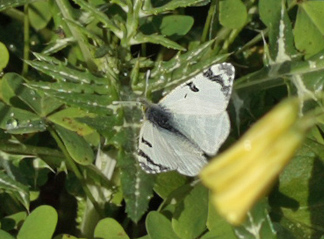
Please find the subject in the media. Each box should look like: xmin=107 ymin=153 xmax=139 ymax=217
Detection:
xmin=0 ymin=171 xmax=29 ymax=209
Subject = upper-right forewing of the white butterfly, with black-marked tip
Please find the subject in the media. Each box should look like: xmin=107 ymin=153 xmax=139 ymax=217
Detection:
xmin=159 ymin=63 xmax=235 ymax=115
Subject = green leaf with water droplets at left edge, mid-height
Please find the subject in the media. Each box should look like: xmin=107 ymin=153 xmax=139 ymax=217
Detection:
xmin=0 ymin=102 xmax=46 ymax=134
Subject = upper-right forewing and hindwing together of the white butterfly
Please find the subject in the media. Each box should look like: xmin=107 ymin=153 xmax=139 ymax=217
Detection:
xmin=159 ymin=63 xmax=234 ymax=155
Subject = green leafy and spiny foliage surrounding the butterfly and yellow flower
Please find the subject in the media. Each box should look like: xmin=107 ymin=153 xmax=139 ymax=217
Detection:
xmin=0 ymin=0 xmax=324 ymax=239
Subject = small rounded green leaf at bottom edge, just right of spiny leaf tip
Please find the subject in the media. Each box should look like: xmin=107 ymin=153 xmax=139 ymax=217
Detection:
xmin=145 ymin=211 xmax=182 ymax=239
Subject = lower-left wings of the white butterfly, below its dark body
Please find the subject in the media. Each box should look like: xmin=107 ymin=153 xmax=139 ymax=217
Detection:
xmin=138 ymin=120 xmax=207 ymax=176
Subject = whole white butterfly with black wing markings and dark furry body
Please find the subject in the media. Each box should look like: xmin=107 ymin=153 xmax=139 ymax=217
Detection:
xmin=138 ymin=63 xmax=235 ymax=176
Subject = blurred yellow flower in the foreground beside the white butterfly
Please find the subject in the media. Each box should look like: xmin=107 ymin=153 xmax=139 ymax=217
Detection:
xmin=200 ymin=99 xmax=308 ymax=225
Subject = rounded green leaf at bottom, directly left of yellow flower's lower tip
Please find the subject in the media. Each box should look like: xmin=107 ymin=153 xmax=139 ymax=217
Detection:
xmin=172 ymin=185 xmax=208 ymax=239
